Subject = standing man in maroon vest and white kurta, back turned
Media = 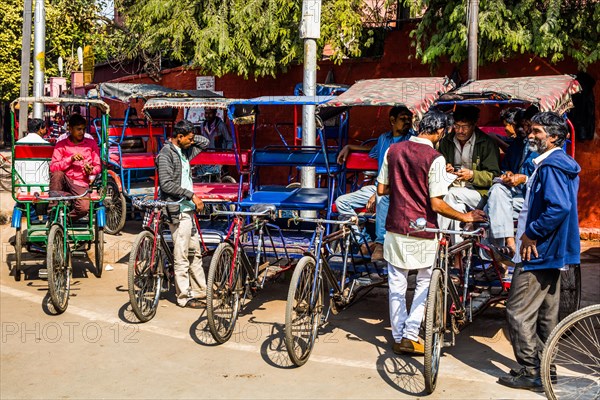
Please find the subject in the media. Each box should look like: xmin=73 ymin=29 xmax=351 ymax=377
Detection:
xmin=377 ymin=111 xmax=486 ymax=354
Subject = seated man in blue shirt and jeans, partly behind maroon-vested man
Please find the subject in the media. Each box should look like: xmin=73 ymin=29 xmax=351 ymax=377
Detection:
xmin=335 ymin=106 xmax=415 ymax=261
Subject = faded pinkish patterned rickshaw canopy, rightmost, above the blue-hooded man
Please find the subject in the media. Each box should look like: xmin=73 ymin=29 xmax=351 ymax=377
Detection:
xmin=438 ymin=75 xmax=581 ymax=114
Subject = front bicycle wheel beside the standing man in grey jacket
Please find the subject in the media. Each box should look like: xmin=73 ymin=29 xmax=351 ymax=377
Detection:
xmin=127 ymin=231 xmax=163 ymax=322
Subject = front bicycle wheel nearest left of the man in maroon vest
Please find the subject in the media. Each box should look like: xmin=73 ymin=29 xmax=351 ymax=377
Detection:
xmin=285 ymin=256 xmax=325 ymax=367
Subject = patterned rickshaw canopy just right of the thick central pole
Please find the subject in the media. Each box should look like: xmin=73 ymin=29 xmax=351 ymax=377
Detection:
xmin=324 ymin=77 xmax=453 ymax=119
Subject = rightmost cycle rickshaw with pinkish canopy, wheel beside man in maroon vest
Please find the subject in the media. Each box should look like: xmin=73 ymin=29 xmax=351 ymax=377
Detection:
xmin=415 ymin=75 xmax=581 ymax=393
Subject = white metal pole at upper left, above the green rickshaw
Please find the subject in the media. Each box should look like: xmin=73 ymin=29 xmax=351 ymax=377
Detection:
xmin=33 ymin=0 xmax=46 ymax=118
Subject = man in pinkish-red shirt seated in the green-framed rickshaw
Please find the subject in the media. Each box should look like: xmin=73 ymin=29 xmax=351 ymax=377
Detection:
xmin=50 ymin=114 xmax=100 ymax=220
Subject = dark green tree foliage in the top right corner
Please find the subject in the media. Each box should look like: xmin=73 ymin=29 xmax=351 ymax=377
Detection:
xmin=405 ymin=0 xmax=600 ymax=69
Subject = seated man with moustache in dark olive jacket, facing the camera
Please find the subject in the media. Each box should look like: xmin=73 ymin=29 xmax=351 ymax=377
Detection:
xmin=439 ymin=106 xmax=500 ymax=243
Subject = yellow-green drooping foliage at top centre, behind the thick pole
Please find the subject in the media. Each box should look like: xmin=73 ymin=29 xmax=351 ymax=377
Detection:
xmin=120 ymin=0 xmax=368 ymax=77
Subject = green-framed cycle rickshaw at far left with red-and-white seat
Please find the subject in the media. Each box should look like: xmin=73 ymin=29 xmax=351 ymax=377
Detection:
xmin=11 ymin=97 xmax=110 ymax=313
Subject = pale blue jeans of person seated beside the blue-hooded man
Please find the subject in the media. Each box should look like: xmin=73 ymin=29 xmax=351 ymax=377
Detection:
xmin=484 ymin=183 xmax=525 ymax=239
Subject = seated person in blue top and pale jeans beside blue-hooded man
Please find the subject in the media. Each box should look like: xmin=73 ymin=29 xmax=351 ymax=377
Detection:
xmin=485 ymin=106 xmax=539 ymax=254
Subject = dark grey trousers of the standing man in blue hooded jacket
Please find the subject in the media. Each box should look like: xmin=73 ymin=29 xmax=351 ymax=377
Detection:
xmin=506 ymin=264 xmax=560 ymax=375
